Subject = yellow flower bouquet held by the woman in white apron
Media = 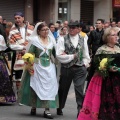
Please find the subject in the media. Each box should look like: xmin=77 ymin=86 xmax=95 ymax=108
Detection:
xmin=22 ymin=53 xmax=35 ymax=75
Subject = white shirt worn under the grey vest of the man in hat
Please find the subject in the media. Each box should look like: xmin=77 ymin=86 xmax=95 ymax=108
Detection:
xmin=56 ymin=34 xmax=90 ymax=67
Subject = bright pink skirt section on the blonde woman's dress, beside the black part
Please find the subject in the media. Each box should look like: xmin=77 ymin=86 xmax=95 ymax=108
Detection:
xmin=78 ymin=75 xmax=103 ymax=120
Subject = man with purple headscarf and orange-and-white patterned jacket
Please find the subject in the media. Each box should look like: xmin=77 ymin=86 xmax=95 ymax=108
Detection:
xmin=9 ymin=12 xmax=34 ymax=99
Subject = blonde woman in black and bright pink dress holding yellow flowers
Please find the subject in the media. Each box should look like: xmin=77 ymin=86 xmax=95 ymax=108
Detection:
xmin=78 ymin=28 xmax=120 ymax=120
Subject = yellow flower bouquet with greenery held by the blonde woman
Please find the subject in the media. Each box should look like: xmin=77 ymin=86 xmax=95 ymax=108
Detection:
xmin=97 ymin=57 xmax=114 ymax=77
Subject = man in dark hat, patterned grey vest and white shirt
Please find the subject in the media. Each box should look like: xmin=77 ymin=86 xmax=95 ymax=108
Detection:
xmin=56 ymin=22 xmax=90 ymax=115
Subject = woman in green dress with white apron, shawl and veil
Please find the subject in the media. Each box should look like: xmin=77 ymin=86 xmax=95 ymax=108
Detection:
xmin=20 ymin=22 xmax=58 ymax=119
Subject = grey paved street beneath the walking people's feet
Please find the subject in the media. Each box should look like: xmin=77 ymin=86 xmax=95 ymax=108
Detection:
xmin=0 ymin=84 xmax=77 ymax=120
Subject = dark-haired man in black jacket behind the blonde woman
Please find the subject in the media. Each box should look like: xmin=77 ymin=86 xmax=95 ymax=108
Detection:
xmin=87 ymin=19 xmax=104 ymax=84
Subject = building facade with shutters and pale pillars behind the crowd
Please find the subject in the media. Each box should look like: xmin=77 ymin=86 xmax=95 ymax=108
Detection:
xmin=0 ymin=0 xmax=120 ymax=24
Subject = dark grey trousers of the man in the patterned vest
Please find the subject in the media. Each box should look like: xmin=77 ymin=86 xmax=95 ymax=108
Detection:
xmin=58 ymin=66 xmax=87 ymax=112
